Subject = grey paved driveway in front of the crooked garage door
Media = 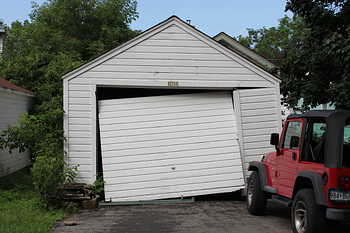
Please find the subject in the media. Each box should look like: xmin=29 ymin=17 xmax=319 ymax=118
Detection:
xmin=51 ymin=197 xmax=349 ymax=233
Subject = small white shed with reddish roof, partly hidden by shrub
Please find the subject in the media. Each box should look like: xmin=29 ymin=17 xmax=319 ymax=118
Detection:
xmin=0 ymin=78 xmax=36 ymax=176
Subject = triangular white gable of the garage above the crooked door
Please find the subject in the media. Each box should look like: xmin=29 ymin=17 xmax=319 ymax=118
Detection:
xmin=63 ymin=16 xmax=280 ymax=87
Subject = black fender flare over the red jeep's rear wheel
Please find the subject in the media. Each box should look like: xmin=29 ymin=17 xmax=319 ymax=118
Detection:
xmin=293 ymin=171 xmax=327 ymax=205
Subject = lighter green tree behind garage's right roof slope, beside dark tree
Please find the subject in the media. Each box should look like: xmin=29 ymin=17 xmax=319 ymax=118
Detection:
xmin=237 ymin=15 xmax=308 ymax=65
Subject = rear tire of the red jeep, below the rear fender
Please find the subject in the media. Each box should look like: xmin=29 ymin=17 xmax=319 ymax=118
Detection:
xmin=292 ymin=189 xmax=326 ymax=233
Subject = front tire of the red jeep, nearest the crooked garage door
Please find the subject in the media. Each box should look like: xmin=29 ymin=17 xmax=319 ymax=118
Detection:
xmin=247 ymin=171 xmax=267 ymax=215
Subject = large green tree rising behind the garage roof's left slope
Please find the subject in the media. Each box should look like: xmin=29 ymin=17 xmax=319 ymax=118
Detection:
xmin=0 ymin=0 xmax=139 ymax=113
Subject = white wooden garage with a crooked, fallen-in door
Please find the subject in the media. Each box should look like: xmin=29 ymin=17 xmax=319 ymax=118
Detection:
xmin=63 ymin=16 xmax=281 ymax=201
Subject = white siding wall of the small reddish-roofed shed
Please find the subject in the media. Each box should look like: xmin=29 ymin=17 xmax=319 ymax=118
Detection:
xmin=0 ymin=91 xmax=35 ymax=176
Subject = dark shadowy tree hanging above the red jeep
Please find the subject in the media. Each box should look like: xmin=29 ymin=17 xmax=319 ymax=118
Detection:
xmin=281 ymin=0 xmax=350 ymax=109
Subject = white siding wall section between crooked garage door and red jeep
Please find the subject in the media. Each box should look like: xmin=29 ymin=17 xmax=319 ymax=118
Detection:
xmin=234 ymin=88 xmax=282 ymax=176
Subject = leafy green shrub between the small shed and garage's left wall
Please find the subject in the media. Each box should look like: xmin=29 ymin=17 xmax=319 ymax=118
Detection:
xmin=0 ymin=109 xmax=78 ymax=207
